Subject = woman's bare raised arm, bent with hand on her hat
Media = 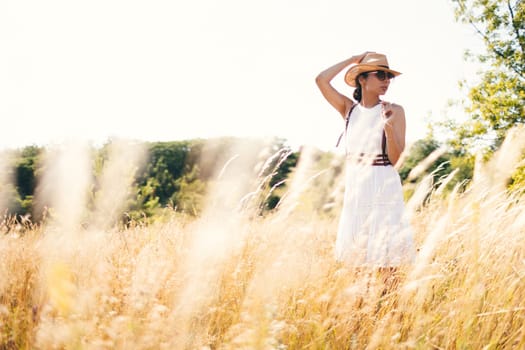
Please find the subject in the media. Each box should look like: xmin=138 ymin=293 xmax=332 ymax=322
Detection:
xmin=315 ymin=52 xmax=368 ymax=118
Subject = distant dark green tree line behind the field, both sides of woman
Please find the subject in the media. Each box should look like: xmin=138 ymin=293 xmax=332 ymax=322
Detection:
xmin=0 ymin=133 xmax=471 ymax=226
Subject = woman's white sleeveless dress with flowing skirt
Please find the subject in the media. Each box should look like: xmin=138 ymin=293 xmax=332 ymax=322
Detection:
xmin=335 ymin=104 xmax=414 ymax=267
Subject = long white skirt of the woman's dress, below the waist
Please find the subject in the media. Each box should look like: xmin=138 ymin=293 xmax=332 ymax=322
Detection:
xmin=335 ymin=162 xmax=414 ymax=267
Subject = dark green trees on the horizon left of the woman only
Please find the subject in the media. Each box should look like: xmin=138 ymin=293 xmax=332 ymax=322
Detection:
xmin=0 ymin=138 xmax=298 ymax=223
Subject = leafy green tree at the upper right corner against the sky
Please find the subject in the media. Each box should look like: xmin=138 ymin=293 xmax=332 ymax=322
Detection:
xmin=452 ymin=0 xmax=525 ymax=149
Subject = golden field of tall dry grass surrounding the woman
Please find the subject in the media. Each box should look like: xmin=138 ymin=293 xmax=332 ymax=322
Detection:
xmin=0 ymin=137 xmax=525 ymax=350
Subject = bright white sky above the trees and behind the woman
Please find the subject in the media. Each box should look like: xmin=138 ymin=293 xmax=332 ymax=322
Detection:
xmin=0 ymin=0 xmax=479 ymax=149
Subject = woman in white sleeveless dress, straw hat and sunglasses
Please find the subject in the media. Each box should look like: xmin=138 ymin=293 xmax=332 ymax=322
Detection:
xmin=316 ymin=52 xmax=413 ymax=268
